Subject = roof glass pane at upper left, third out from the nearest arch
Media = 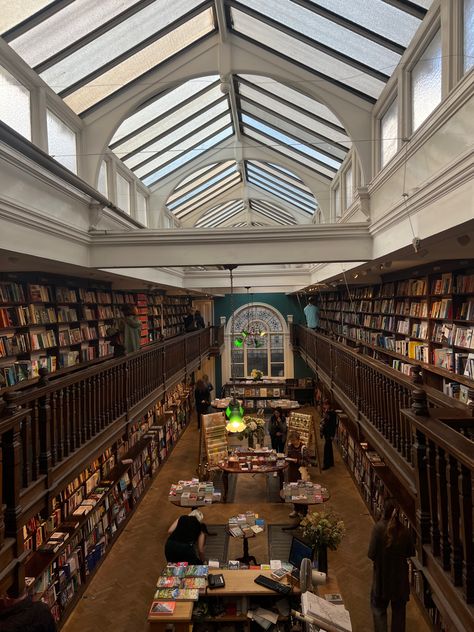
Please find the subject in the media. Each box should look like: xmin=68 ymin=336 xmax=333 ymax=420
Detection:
xmin=10 ymin=0 xmax=143 ymax=68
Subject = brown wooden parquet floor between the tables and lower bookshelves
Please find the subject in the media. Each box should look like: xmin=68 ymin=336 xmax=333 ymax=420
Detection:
xmin=63 ymin=410 xmax=430 ymax=632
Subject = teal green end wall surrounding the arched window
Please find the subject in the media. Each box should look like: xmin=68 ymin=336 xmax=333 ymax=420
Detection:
xmin=214 ymin=292 xmax=313 ymax=393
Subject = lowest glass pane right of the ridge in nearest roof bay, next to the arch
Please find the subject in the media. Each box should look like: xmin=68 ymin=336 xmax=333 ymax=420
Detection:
xmin=231 ymin=8 xmax=385 ymax=99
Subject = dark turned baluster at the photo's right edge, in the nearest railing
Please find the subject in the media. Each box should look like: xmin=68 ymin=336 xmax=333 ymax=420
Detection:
xmin=459 ymin=465 xmax=474 ymax=604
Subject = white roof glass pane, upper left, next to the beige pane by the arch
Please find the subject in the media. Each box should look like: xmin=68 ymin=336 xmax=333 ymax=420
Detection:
xmin=41 ymin=0 xmax=206 ymax=92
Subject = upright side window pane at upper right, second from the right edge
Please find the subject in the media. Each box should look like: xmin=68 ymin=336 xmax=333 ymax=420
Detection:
xmin=411 ymin=31 xmax=441 ymax=131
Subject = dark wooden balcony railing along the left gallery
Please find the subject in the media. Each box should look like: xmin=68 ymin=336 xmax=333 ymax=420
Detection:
xmin=0 ymin=327 xmax=218 ymax=596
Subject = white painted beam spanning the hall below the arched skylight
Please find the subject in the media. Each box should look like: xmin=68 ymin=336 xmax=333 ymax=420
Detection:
xmin=90 ymin=223 xmax=372 ymax=268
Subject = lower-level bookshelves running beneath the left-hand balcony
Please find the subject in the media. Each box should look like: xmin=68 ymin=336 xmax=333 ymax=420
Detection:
xmin=23 ymin=384 xmax=190 ymax=623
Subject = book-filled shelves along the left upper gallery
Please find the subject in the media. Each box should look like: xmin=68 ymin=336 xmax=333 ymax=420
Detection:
xmin=0 ymin=273 xmax=193 ymax=389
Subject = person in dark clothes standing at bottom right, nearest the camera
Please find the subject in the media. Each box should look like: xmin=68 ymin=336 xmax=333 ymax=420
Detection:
xmin=368 ymin=498 xmax=415 ymax=632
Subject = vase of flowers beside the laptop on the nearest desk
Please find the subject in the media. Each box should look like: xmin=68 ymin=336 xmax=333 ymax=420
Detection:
xmin=300 ymin=511 xmax=346 ymax=574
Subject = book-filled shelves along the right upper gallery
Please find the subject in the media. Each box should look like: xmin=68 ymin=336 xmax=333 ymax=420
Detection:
xmin=318 ymin=262 xmax=474 ymax=401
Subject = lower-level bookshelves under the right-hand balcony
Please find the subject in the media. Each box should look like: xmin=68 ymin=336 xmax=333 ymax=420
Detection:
xmin=336 ymin=411 xmax=445 ymax=632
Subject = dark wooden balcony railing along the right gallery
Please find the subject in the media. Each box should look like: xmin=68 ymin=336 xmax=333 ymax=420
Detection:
xmin=292 ymin=325 xmax=474 ymax=629
